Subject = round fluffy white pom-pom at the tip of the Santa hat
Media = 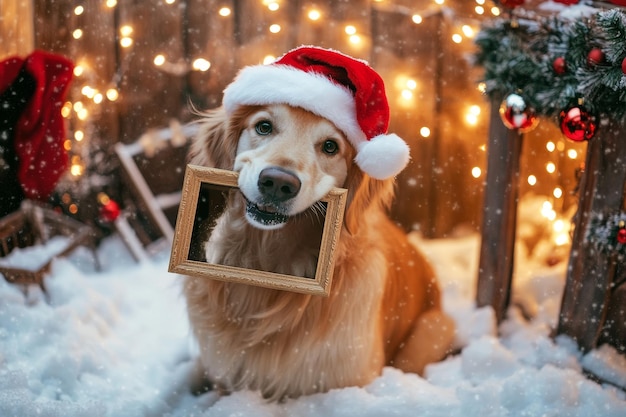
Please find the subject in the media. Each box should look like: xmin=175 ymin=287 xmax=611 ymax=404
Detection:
xmin=354 ymin=133 xmax=410 ymax=180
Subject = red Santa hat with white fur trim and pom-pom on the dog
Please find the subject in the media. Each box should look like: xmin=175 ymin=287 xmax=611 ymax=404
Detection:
xmin=223 ymin=46 xmax=409 ymax=179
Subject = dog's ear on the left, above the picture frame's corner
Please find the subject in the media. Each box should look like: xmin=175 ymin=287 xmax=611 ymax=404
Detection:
xmin=188 ymin=107 xmax=238 ymax=170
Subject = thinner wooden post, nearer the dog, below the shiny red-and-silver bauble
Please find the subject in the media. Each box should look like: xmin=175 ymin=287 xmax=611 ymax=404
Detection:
xmin=476 ymin=98 xmax=523 ymax=322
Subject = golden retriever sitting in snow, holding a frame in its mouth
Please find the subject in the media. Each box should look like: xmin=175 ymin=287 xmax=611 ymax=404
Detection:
xmin=184 ymin=45 xmax=454 ymax=400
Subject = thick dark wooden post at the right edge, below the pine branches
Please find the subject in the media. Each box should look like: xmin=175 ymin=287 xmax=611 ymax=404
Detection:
xmin=557 ymin=119 xmax=626 ymax=352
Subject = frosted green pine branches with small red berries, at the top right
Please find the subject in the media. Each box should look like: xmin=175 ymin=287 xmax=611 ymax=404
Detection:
xmin=476 ymin=9 xmax=626 ymax=120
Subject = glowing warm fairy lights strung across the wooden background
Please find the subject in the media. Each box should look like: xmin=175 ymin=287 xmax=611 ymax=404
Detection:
xmin=62 ymin=0 xmax=580 ymax=244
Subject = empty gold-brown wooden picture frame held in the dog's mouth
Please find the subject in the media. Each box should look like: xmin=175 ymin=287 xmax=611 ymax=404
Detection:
xmin=169 ymin=165 xmax=347 ymax=296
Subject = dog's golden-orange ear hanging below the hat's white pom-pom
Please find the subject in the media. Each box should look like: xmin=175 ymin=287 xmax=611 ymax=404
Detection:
xmin=344 ymin=168 xmax=394 ymax=235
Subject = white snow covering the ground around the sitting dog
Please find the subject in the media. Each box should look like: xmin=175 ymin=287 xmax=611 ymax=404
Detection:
xmin=0 ymin=229 xmax=626 ymax=417
